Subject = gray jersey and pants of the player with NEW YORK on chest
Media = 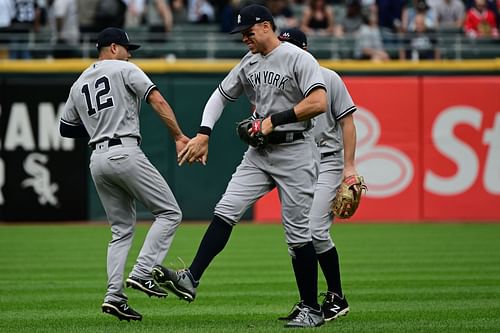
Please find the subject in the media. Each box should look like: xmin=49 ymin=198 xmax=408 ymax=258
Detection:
xmin=215 ymin=43 xmax=325 ymax=247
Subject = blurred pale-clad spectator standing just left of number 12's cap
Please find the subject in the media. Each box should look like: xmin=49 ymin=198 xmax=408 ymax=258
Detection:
xmin=47 ymin=0 xmax=80 ymax=58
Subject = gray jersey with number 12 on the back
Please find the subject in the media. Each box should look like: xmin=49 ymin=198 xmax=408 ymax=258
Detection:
xmin=61 ymin=60 xmax=156 ymax=144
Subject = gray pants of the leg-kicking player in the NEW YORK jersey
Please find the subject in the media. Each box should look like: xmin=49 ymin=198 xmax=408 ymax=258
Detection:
xmin=214 ymin=137 xmax=319 ymax=248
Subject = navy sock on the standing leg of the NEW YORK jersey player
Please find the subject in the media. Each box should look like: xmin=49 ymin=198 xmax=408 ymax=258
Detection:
xmin=292 ymin=242 xmax=320 ymax=309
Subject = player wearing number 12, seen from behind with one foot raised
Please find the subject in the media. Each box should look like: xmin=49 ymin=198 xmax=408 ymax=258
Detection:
xmin=60 ymin=28 xmax=189 ymax=321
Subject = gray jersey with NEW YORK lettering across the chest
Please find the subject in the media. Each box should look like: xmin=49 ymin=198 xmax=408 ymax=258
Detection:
xmin=218 ymin=43 xmax=326 ymax=131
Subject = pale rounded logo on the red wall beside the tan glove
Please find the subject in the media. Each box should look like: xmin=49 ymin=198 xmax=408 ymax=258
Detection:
xmin=354 ymin=107 xmax=414 ymax=198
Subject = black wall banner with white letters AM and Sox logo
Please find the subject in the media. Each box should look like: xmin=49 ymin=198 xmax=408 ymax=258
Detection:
xmin=0 ymin=78 xmax=88 ymax=221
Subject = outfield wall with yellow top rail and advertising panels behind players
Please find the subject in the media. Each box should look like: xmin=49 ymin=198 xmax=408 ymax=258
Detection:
xmin=0 ymin=59 xmax=500 ymax=222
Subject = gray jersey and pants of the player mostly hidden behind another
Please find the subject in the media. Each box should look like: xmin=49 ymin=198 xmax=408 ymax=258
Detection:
xmin=310 ymin=67 xmax=356 ymax=253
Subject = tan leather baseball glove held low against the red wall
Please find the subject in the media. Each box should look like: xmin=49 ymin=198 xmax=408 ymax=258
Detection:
xmin=331 ymin=175 xmax=368 ymax=219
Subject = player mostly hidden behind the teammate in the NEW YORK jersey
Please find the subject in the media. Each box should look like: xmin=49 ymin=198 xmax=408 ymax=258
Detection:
xmin=278 ymin=29 xmax=357 ymax=321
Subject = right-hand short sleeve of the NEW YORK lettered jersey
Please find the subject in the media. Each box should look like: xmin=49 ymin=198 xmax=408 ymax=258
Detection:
xmin=294 ymin=52 xmax=326 ymax=96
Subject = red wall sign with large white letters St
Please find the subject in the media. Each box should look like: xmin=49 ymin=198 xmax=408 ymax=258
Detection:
xmin=422 ymin=77 xmax=500 ymax=220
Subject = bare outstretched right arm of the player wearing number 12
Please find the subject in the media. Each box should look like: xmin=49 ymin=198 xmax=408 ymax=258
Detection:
xmin=147 ymin=89 xmax=189 ymax=153
